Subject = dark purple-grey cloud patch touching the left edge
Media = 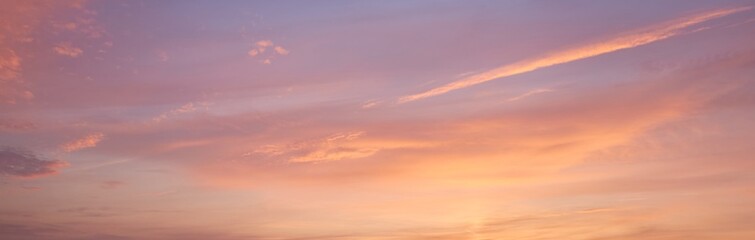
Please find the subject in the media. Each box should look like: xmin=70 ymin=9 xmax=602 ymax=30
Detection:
xmin=0 ymin=147 xmax=68 ymax=177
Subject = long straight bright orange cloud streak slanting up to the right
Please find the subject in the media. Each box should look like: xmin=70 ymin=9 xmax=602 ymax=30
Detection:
xmin=398 ymin=7 xmax=751 ymax=103
